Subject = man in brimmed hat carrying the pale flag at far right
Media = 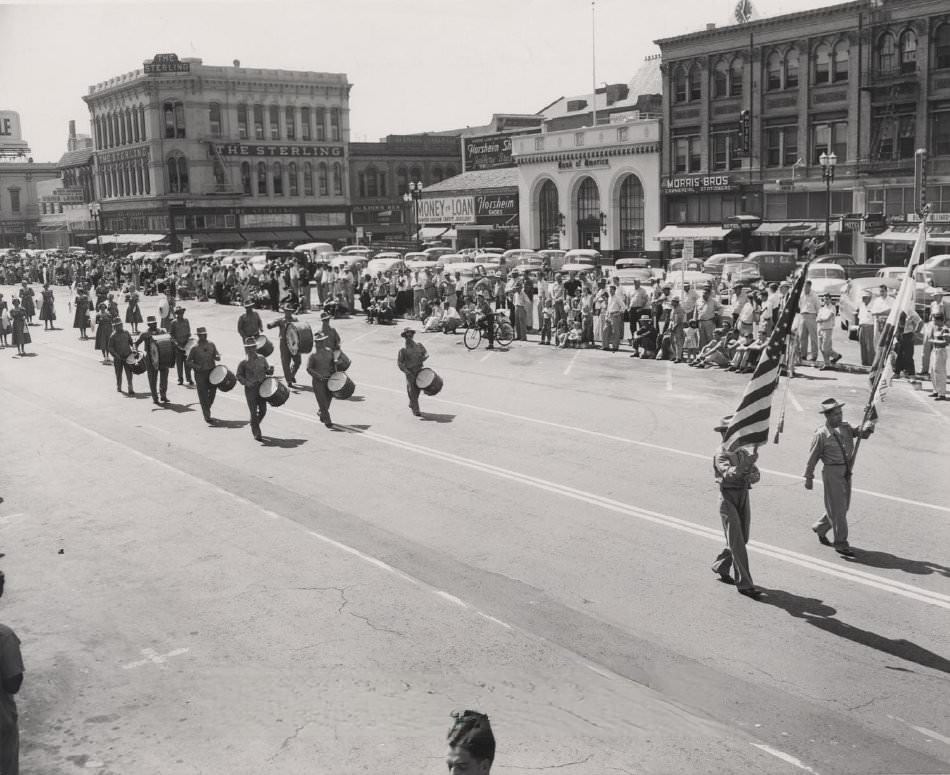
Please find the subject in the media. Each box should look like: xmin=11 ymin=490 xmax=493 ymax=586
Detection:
xmin=805 ymin=398 xmax=874 ymax=557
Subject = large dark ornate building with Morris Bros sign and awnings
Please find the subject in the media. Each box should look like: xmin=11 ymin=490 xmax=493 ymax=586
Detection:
xmin=657 ymin=0 xmax=950 ymax=263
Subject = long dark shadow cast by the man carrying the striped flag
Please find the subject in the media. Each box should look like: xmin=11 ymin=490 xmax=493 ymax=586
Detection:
xmin=759 ymin=587 xmax=950 ymax=674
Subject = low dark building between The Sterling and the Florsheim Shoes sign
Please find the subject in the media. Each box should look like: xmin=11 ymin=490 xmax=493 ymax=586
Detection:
xmin=349 ymin=133 xmax=462 ymax=241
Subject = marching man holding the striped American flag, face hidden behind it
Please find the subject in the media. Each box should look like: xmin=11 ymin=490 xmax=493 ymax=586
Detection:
xmin=712 ymin=414 xmax=761 ymax=598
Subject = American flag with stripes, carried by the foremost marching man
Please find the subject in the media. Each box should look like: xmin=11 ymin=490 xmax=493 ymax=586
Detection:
xmin=723 ymin=262 xmax=811 ymax=449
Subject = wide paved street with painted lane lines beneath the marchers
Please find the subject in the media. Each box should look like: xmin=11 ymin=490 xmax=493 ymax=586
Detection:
xmin=0 ymin=288 xmax=950 ymax=775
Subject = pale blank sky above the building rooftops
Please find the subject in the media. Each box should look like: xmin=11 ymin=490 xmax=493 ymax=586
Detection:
xmin=0 ymin=0 xmax=836 ymax=161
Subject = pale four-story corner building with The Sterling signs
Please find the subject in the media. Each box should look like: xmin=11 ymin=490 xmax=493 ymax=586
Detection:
xmin=83 ymin=54 xmax=350 ymax=247
